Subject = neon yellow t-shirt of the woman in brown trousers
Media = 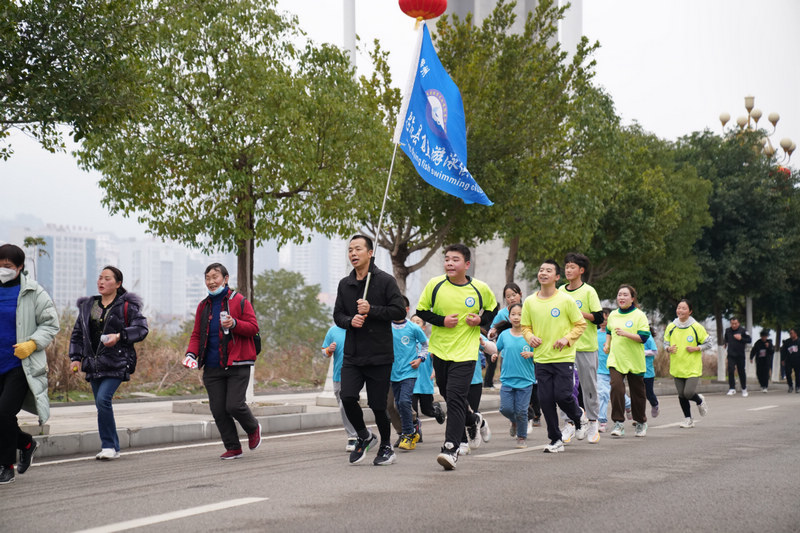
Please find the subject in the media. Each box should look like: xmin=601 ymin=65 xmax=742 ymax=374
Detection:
xmin=606 ymin=307 xmax=650 ymax=375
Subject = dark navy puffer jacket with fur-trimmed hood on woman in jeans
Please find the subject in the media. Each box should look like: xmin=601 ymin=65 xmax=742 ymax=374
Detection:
xmin=69 ymin=292 xmax=148 ymax=381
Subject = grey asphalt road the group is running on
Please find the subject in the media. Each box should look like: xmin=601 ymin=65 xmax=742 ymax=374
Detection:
xmin=0 ymin=392 xmax=800 ymax=533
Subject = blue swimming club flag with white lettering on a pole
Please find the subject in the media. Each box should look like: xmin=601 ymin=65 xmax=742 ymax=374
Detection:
xmin=394 ymin=23 xmax=492 ymax=205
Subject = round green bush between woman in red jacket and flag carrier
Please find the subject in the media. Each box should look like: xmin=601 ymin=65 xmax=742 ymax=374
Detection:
xmin=253 ymin=269 xmax=331 ymax=353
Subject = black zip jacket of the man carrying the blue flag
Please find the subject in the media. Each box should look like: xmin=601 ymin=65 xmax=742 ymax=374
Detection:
xmin=333 ymin=264 xmax=406 ymax=366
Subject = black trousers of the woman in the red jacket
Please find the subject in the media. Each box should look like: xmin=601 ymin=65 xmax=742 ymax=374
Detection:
xmin=203 ymin=365 xmax=258 ymax=450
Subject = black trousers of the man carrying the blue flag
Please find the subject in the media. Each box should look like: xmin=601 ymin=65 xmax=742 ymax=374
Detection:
xmin=340 ymin=361 xmax=392 ymax=445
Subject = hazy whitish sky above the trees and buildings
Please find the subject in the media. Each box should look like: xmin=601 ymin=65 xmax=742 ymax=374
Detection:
xmin=0 ymin=0 xmax=800 ymax=237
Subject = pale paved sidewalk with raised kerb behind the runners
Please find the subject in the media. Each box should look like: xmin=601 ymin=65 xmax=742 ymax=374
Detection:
xmin=19 ymin=378 xmax=768 ymax=458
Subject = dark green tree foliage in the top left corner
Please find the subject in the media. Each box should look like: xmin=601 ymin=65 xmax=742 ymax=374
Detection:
xmin=0 ymin=0 xmax=142 ymax=159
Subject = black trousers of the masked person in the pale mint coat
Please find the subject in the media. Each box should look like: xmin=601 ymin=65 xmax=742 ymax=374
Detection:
xmin=0 ymin=367 xmax=33 ymax=466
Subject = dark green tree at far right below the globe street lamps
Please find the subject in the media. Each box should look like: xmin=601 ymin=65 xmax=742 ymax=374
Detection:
xmin=678 ymin=130 xmax=798 ymax=344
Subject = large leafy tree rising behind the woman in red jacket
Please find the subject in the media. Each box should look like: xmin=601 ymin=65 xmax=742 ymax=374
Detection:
xmin=80 ymin=0 xmax=390 ymax=297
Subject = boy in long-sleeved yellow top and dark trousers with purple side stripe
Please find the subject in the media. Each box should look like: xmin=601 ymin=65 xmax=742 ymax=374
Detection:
xmin=521 ymin=259 xmax=587 ymax=453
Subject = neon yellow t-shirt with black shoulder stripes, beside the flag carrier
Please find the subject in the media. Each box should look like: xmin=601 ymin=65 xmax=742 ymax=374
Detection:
xmin=417 ymin=275 xmax=497 ymax=362
